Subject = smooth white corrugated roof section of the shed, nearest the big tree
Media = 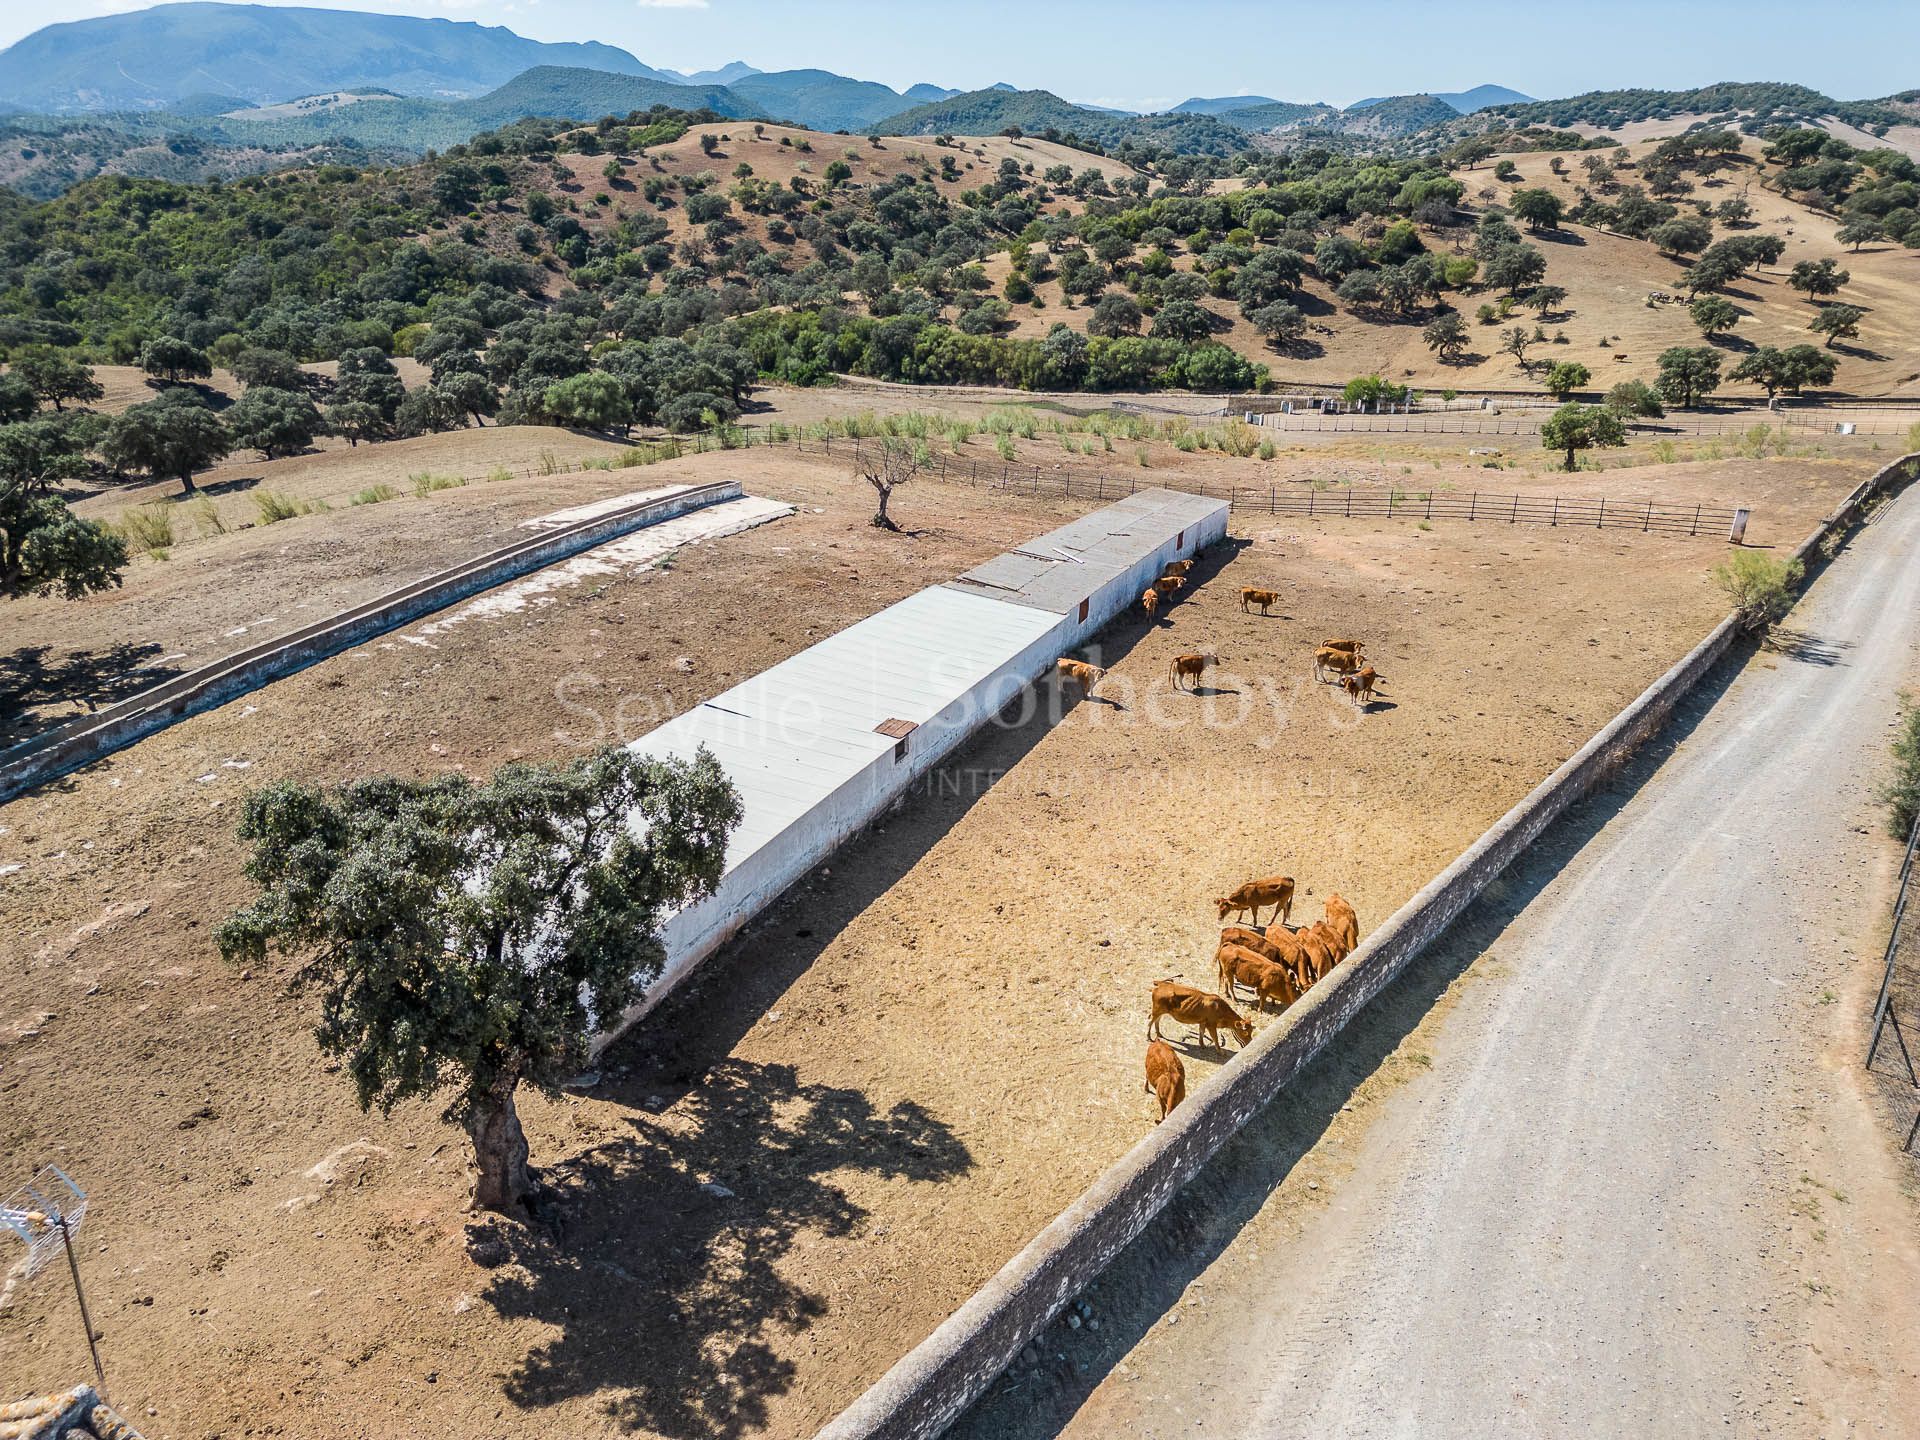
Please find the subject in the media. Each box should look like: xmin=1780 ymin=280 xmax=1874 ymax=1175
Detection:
xmin=632 ymin=586 xmax=1054 ymax=866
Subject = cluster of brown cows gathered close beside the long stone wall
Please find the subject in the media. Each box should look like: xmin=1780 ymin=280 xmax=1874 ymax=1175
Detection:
xmin=1146 ymin=876 xmax=1359 ymax=1119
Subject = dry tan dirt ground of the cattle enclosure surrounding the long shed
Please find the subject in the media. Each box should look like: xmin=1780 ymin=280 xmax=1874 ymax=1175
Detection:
xmin=0 ymin=443 xmax=1870 ymax=1440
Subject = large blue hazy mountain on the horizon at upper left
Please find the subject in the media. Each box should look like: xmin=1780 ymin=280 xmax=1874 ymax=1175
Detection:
xmin=0 ymin=0 xmax=670 ymax=113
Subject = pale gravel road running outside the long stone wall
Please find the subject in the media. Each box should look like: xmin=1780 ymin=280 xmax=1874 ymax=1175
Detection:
xmin=960 ymin=480 xmax=1920 ymax=1436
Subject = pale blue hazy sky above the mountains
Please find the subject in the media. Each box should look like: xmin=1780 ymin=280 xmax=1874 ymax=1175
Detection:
xmin=0 ymin=0 xmax=1920 ymax=109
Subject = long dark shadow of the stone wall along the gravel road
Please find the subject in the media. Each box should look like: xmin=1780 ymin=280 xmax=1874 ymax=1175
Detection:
xmin=947 ymin=647 xmax=1747 ymax=1440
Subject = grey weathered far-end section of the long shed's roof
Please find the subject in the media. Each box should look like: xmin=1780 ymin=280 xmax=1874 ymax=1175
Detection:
xmin=945 ymin=490 xmax=1221 ymax=614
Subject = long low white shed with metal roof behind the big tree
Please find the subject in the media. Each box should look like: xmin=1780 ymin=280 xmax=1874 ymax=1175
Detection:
xmin=601 ymin=490 xmax=1227 ymax=1044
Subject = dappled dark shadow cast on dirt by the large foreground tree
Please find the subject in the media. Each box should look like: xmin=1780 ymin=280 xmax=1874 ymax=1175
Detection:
xmin=484 ymin=1058 xmax=973 ymax=1440
